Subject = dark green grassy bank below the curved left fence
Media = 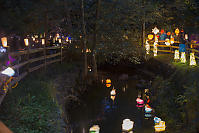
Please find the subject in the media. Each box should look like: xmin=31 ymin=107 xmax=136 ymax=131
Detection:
xmin=0 ymin=63 xmax=81 ymax=133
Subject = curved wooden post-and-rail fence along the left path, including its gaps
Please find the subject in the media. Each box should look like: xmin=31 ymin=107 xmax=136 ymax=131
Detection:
xmin=0 ymin=45 xmax=67 ymax=104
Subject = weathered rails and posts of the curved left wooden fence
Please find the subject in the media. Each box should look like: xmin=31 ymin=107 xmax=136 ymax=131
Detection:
xmin=0 ymin=46 xmax=66 ymax=104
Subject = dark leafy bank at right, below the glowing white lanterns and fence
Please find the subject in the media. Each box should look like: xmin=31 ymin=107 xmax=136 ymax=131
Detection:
xmin=153 ymin=64 xmax=199 ymax=133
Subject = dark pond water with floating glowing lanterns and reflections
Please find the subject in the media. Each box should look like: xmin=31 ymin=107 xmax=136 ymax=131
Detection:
xmin=70 ymin=73 xmax=154 ymax=133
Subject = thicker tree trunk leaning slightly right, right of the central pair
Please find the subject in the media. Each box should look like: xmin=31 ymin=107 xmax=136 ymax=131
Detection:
xmin=91 ymin=0 xmax=101 ymax=79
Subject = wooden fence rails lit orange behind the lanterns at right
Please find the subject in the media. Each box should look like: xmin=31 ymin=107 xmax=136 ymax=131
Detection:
xmin=150 ymin=41 xmax=199 ymax=59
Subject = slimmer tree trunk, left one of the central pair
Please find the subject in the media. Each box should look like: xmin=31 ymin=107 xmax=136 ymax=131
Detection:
xmin=81 ymin=0 xmax=88 ymax=78
